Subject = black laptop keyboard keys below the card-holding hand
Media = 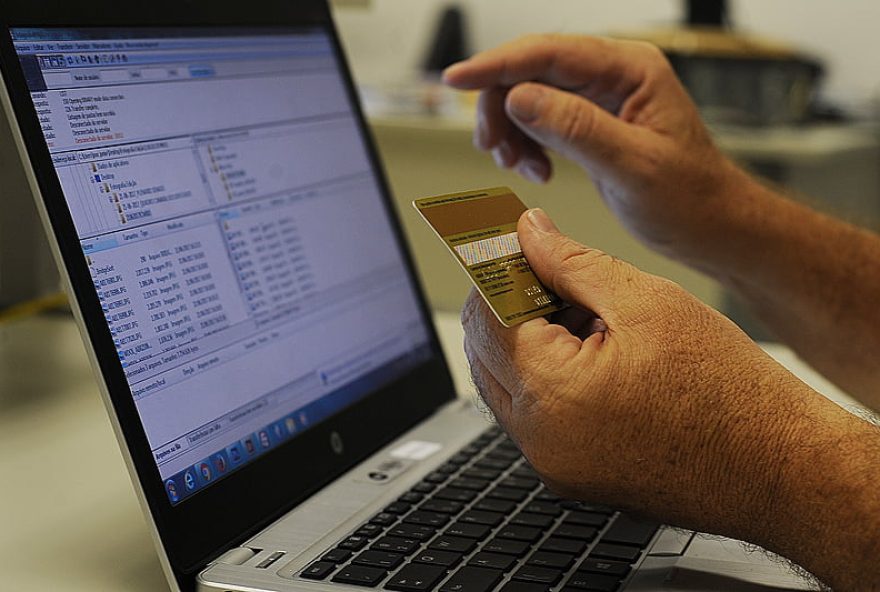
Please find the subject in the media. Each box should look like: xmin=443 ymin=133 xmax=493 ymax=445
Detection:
xmin=299 ymin=427 xmax=659 ymax=592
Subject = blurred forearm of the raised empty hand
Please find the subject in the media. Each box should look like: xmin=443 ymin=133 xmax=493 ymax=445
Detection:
xmin=685 ymin=164 xmax=880 ymax=410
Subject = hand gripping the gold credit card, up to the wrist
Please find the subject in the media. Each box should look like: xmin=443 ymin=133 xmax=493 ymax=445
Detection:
xmin=462 ymin=210 xmax=834 ymax=542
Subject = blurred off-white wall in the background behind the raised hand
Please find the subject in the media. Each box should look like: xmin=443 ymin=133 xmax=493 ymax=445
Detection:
xmin=337 ymin=0 xmax=880 ymax=108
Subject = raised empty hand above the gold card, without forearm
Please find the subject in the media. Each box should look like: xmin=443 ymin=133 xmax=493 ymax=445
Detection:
xmin=444 ymin=35 xmax=748 ymax=264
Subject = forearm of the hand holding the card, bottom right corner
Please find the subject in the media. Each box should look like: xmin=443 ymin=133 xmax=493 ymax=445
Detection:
xmin=752 ymin=400 xmax=880 ymax=592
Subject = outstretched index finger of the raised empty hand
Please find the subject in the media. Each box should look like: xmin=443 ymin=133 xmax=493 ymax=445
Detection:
xmin=443 ymin=35 xmax=645 ymax=96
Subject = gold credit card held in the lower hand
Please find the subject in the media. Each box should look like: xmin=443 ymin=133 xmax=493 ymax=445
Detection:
xmin=413 ymin=187 xmax=565 ymax=327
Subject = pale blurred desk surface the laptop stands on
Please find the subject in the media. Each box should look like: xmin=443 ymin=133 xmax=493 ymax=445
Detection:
xmin=0 ymin=314 xmax=860 ymax=592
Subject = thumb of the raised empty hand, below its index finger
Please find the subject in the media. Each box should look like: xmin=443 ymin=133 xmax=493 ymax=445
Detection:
xmin=505 ymin=82 xmax=644 ymax=170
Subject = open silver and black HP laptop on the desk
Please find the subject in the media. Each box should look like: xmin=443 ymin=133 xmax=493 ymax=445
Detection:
xmin=0 ymin=0 xmax=802 ymax=592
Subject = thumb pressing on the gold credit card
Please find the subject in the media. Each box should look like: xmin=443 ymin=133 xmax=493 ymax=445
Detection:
xmin=517 ymin=208 xmax=637 ymax=325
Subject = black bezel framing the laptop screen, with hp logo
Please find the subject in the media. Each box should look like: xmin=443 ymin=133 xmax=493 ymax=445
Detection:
xmin=0 ymin=0 xmax=454 ymax=590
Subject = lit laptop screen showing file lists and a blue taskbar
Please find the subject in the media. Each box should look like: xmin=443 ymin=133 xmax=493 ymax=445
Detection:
xmin=12 ymin=28 xmax=430 ymax=504
